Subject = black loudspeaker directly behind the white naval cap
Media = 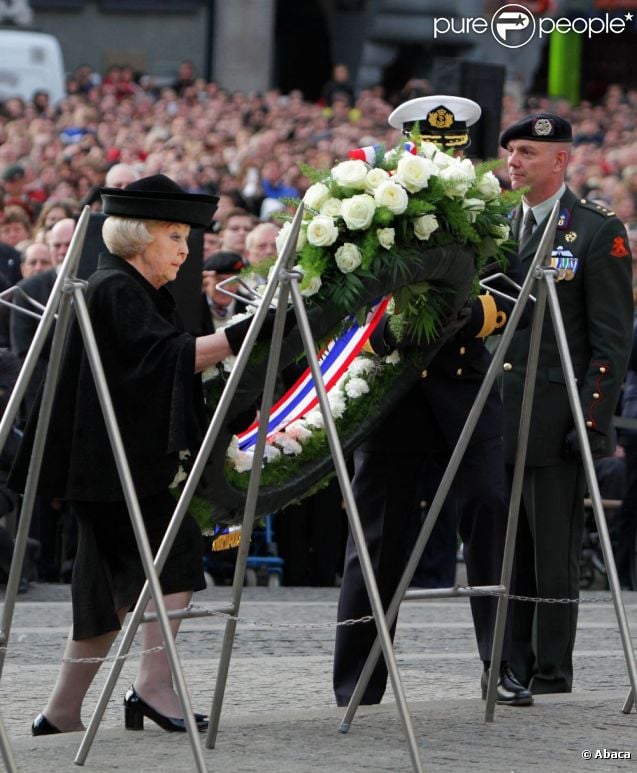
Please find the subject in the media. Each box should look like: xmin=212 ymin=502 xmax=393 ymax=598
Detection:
xmin=431 ymin=56 xmax=505 ymax=159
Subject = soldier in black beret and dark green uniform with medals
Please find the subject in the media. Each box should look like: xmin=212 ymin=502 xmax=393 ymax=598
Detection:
xmin=500 ymin=113 xmax=633 ymax=693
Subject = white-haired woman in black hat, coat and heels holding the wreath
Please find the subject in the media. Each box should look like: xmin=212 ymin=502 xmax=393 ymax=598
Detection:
xmin=20 ymin=175 xmax=256 ymax=735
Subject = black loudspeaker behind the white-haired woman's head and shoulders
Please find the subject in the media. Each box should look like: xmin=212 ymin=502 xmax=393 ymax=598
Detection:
xmin=77 ymin=212 xmax=203 ymax=335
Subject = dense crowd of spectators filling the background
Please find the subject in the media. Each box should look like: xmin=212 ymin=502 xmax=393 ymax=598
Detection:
xmin=0 ymin=63 xmax=637 ymax=596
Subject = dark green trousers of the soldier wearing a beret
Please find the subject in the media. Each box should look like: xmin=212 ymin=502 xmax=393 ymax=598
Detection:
xmin=511 ymin=462 xmax=586 ymax=693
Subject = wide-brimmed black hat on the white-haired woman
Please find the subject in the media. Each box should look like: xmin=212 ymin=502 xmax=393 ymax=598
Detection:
xmin=101 ymin=174 xmax=219 ymax=228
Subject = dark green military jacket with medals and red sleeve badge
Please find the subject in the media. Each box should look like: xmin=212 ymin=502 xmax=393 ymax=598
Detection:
xmin=503 ymin=188 xmax=633 ymax=466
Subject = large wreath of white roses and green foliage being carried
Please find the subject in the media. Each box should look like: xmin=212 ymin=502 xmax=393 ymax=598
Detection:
xmin=176 ymin=142 xmax=516 ymax=525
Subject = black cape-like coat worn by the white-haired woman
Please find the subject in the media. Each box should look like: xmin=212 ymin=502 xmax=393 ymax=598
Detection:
xmin=11 ymin=254 xmax=205 ymax=502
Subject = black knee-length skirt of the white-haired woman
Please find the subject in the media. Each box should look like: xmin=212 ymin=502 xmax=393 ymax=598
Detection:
xmin=71 ymin=491 xmax=206 ymax=640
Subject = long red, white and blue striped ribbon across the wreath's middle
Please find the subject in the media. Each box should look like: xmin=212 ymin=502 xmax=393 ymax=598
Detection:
xmin=238 ymin=295 xmax=390 ymax=451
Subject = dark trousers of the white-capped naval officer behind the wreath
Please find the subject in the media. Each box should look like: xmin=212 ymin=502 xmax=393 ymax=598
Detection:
xmin=333 ymin=428 xmax=508 ymax=705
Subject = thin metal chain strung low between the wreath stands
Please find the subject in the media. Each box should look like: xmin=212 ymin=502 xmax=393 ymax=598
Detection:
xmin=0 ymin=585 xmax=610 ymax=663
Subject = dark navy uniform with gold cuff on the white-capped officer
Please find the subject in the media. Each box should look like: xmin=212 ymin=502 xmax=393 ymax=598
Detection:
xmin=334 ymin=257 xmax=521 ymax=705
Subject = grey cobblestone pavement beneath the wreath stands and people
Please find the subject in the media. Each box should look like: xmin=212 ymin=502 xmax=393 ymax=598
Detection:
xmin=0 ymin=585 xmax=637 ymax=773
